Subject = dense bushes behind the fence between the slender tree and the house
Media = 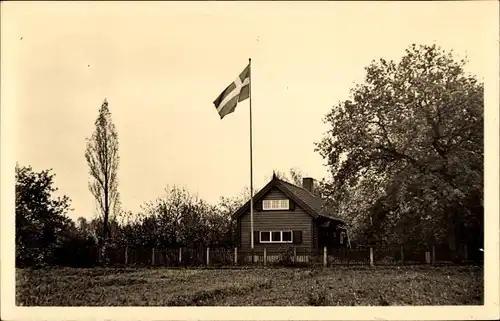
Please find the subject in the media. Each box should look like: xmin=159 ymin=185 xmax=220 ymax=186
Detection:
xmin=72 ymin=186 xmax=243 ymax=251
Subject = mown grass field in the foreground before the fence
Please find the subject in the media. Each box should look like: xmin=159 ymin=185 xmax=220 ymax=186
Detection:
xmin=16 ymin=266 xmax=483 ymax=306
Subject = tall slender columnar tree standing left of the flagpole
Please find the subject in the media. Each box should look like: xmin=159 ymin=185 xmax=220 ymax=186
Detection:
xmin=85 ymin=99 xmax=120 ymax=260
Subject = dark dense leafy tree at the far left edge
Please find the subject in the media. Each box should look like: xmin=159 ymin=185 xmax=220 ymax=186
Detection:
xmin=15 ymin=164 xmax=73 ymax=265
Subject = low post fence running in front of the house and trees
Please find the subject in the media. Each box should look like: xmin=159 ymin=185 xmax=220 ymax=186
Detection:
xmin=104 ymin=246 xmax=482 ymax=267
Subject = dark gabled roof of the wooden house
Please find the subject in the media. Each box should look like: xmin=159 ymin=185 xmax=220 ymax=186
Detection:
xmin=232 ymin=172 xmax=342 ymax=222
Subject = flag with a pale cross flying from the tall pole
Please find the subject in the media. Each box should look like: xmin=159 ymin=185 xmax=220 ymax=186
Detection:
xmin=214 ymin=64 xmax=250 ymax=119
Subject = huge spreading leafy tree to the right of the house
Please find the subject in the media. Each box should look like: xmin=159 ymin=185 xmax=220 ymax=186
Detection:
xmin=317 ymin=45 xmax=484 ymax=248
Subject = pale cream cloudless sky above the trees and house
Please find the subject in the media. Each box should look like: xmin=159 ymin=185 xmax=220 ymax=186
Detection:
xmin=1 ymin=1 xmax=498 ymax=219
